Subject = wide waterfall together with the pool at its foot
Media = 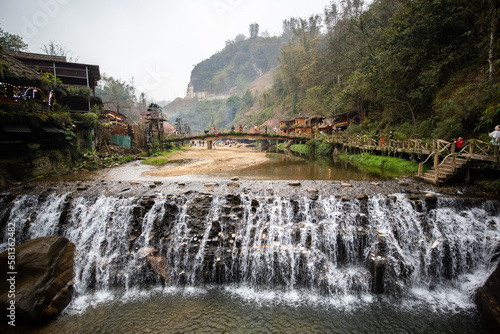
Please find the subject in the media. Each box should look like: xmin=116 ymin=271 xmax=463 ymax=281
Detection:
xmin=0 ymin=192 xmax=500 ymax=333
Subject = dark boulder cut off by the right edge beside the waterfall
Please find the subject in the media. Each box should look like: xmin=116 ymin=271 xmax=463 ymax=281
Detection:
xmin=476 ymin=263 xmax=500 ymax=333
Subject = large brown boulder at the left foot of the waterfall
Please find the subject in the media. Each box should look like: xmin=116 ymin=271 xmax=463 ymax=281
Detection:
xmin=0 ymin=236 xmax=75 ymax=326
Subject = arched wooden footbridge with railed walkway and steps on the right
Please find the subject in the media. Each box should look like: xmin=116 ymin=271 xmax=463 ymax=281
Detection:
xmin=165 ymin=132 xmax=499 ymax=184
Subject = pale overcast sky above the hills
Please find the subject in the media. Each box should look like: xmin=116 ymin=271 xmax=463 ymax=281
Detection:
xmin=0 ymin=0 xmax=330 ymax=101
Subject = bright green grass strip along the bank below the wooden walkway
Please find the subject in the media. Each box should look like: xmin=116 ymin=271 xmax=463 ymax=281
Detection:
xmin=338 ymin=153 xmax=425 ymax=174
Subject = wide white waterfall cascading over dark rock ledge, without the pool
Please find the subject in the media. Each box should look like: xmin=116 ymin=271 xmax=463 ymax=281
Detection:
xmin=0 ymin=193 xmax=500 ymax=306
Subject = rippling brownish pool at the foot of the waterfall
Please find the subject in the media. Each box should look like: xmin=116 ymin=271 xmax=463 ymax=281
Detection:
xmin=32 ymin=287 xmax=487 ymax=334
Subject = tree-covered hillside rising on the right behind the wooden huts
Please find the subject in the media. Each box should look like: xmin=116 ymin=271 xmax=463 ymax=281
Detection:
xmin=236 ymin=0 xmax=500 ymax=138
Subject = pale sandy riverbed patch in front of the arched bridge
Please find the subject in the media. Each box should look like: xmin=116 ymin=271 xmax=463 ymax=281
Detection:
xmin=143 ymin=145 xmax=269 ymax=177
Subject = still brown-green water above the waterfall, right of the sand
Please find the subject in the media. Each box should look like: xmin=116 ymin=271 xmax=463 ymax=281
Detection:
xmin=220 ymin=154 xmax=402 ymax=181
